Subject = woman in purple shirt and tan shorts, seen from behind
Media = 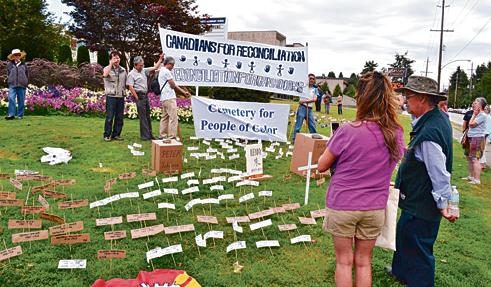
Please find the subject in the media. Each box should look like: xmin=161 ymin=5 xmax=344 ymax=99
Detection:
xmin=318 ymin=72 xmax=404 ymax=286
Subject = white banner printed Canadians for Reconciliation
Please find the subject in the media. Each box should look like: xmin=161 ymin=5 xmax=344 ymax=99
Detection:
xmin=160 ymin=28 xmax=308 ymax=97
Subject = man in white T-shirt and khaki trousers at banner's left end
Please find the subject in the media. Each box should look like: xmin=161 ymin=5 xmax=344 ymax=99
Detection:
xmin=158 ymin=57 xmax=191 ymax=139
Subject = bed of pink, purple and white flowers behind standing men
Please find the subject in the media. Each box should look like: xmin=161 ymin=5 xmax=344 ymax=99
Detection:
xmin=0 ymin=85 xmax=193 ymax=123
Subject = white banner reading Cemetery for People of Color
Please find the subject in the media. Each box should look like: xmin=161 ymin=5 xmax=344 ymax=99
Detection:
xmin=191 ymin=97 xmax=290 ymax=142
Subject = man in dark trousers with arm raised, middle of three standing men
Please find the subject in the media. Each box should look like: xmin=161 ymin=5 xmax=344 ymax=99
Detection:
xmin=126 ymin=54 xmax=164 ymax=140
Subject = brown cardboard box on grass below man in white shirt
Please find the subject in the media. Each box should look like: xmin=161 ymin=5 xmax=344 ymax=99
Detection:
xmin=152 ymin=140 xmax=183 ymax=174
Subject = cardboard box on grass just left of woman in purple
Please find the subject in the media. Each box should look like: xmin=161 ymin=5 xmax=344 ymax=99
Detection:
xmin=290 ymin=133 xmax=329 ymax=178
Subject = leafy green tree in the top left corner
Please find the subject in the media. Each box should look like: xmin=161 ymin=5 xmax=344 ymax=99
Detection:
xmin=0 ymin=0 xmax=65 ymax=61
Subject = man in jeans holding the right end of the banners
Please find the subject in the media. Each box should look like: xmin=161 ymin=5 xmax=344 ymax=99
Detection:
xmin=292 ymin=74 xmax=320 ymax=142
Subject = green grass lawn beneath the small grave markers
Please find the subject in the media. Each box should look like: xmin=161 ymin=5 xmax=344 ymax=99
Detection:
xmin=0 ymin=105 xmax=491 ymax=287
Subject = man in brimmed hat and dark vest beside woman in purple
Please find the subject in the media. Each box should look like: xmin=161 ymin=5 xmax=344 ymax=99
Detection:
xmin=387 ymin=76 xmax=458 ymax=286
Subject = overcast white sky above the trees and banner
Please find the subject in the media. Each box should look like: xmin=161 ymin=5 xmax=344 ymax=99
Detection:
xmin=47 ymin=0 xmax=491 ymax=89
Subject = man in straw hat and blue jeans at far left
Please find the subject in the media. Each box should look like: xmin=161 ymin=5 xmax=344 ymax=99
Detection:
xmin=5 ymin=49 xmax=29 ymax=120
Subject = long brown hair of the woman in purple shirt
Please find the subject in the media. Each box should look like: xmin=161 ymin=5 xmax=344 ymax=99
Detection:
xmin=355 ymin=71 xmax=402 ymax=161
